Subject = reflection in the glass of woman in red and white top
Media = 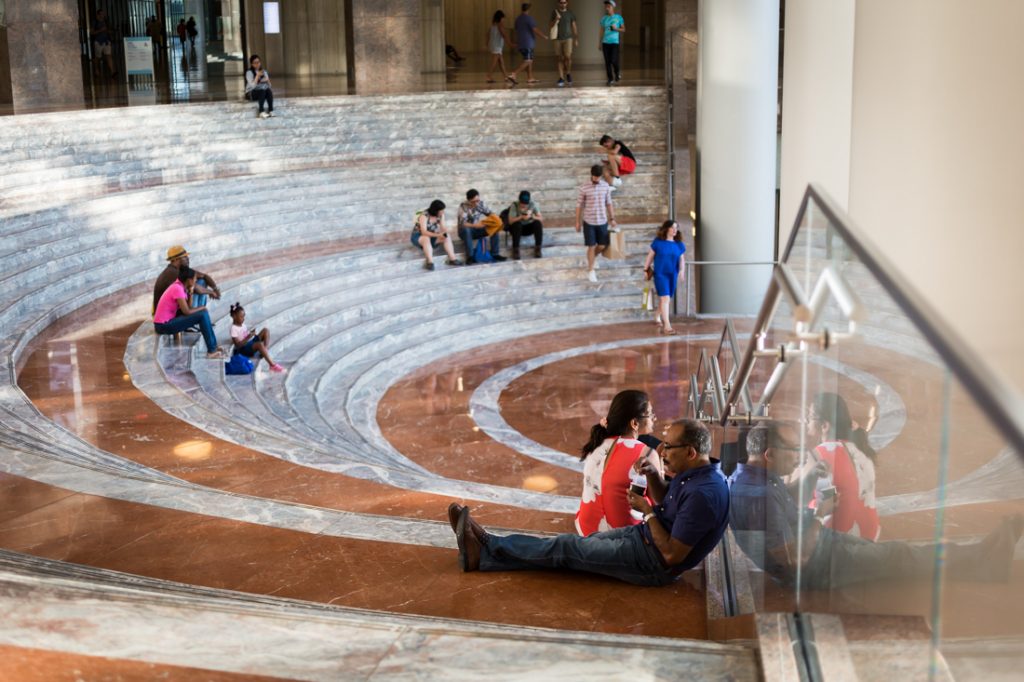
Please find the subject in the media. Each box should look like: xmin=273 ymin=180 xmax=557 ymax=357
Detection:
xmin=807 ymin=392 xmax=882 ymax=541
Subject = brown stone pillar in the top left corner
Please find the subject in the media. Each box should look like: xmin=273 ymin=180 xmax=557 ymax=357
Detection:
xmin=0 ymin=0 xmax=85 ymax=113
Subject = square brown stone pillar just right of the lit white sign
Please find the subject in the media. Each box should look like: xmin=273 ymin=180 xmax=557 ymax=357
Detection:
xmin=351 ymin=0 xmax=423 ymax=94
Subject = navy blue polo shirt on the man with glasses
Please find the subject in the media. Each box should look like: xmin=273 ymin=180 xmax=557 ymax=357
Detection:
xmin=640 ymin=464 xmax=729 ymax=572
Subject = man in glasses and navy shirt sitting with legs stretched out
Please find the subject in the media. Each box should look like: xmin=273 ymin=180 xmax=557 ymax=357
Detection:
xmin=449 ymin=419 xmax=729 ymax=586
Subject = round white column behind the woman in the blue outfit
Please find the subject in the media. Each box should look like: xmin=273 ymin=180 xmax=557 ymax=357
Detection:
xmin=697 ymin=0 xmax=779 ymax=313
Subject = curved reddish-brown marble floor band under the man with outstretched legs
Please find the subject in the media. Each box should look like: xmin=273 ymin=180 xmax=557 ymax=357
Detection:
xmin=0 ymin=476 xmax=707 ymax=639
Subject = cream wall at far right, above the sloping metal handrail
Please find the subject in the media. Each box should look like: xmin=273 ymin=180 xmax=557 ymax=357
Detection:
xmin=781 ymin=0 xmax=1024 ymax=391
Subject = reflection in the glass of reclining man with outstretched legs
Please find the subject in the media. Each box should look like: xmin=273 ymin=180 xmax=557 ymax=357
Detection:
xmin=730 ymin=422 xmax=1024 ymax=589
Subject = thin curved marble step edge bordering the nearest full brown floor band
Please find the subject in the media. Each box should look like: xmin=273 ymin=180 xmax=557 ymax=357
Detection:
xmin=0 ymin=548 xmax=750 ymax=655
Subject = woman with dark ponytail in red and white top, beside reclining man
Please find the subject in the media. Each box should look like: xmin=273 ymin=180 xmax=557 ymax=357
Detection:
xmin=575 ymin=390 xmax=662 ymax=536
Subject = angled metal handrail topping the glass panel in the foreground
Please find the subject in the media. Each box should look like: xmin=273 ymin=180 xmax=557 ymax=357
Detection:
xmin=721 ymin=183 xmax=1024 ymax=458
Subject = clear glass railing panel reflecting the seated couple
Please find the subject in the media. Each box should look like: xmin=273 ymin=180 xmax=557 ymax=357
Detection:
xmin=731 ymin=186 xmax=1024 ymax=679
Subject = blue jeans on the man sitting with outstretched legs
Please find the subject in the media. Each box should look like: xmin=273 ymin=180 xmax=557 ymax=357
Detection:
xmin=480 ymin=525 xmax=678 ymax=586
